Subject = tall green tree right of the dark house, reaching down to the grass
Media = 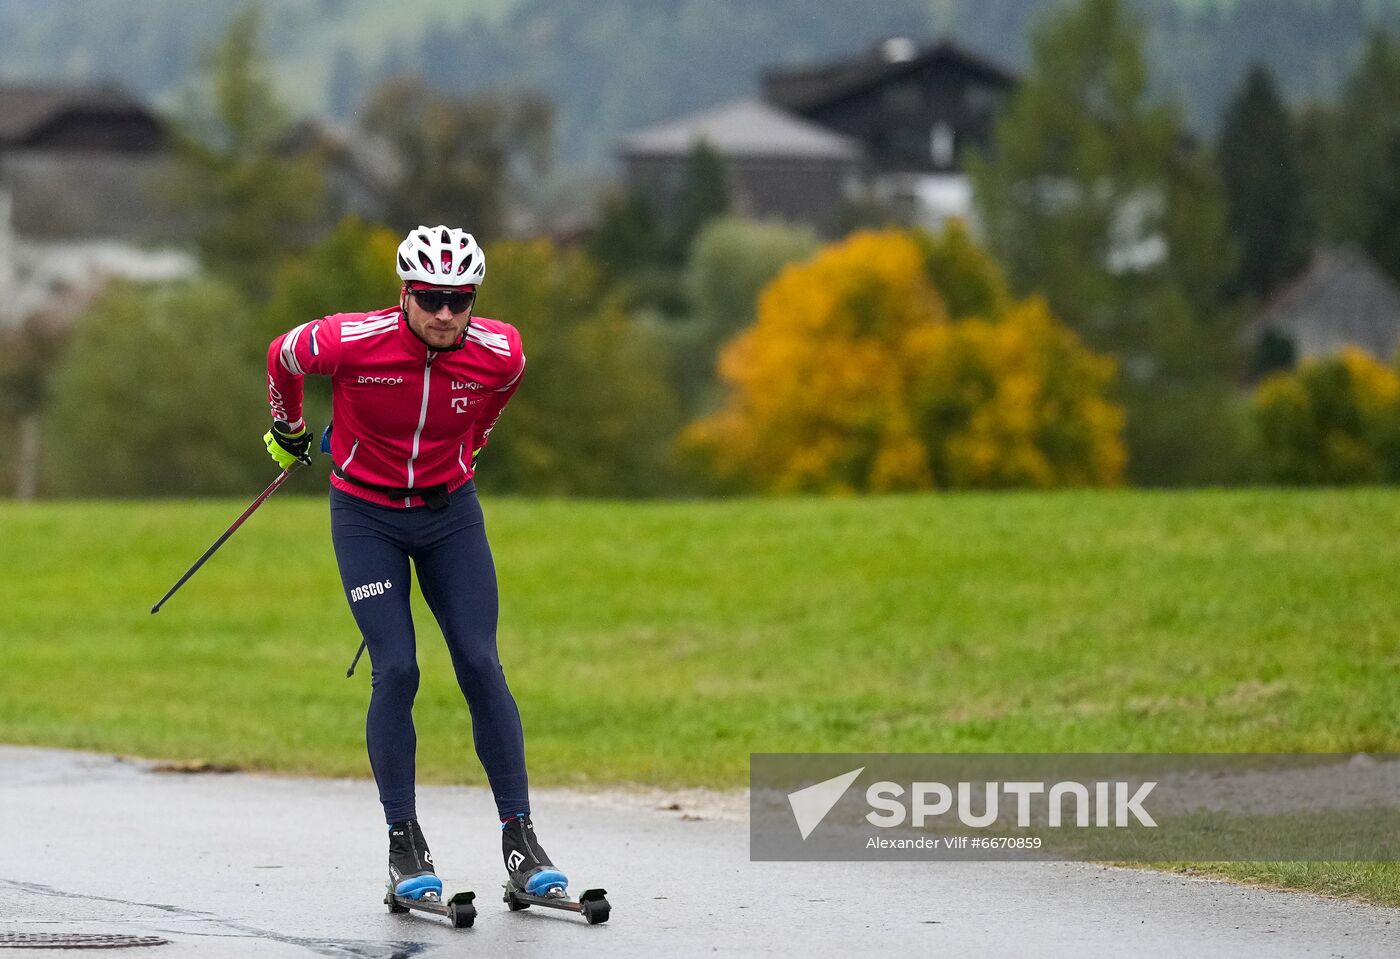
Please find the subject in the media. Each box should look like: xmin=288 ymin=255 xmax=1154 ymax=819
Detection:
xmin=973 ymin=0 xmax=1238 ymax=483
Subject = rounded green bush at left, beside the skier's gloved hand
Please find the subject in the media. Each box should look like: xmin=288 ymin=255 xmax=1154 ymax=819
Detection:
xmin=45 ymin=279 xmax=270 ymax=496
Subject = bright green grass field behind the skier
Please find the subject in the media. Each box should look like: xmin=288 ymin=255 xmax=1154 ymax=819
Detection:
xmin=0 ymin=490 xmax=1400 ymax=904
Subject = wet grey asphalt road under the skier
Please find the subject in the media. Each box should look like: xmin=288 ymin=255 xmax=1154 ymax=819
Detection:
xmin=0 ymin=746 xmax=1400 ymax=959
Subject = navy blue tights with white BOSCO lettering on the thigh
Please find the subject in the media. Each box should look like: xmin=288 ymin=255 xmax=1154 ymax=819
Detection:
xmin=330 ymin=483 xmax=529 ymax=823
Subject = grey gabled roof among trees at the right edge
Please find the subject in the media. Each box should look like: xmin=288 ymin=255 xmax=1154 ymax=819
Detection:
xmin=1254 ymin=246 xmax=1400 ymax=360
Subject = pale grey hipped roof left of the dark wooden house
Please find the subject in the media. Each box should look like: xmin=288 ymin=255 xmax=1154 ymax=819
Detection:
xmin=619 ymin=99 xmax=862 ymax=162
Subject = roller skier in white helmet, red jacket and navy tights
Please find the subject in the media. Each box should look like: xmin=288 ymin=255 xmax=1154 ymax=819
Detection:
xmin=263 ymin=227 xmax=568 ymax=899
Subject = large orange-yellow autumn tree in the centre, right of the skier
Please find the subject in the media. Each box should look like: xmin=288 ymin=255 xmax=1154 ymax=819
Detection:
xmin=682 ymin=231 xmax=1126 ymax=493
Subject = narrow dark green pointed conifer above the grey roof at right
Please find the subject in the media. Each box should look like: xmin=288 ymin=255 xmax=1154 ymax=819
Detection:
xmin=1218 ymin=63 xmax=1310 ymax=300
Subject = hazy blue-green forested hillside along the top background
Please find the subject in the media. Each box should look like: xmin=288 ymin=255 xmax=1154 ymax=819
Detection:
xmin=0 ymin=0 xmax=1400 ymax=171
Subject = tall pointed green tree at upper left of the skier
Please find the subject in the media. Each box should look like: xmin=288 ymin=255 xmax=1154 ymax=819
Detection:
xmin=168 ymin=7 xmax=323 ymax=297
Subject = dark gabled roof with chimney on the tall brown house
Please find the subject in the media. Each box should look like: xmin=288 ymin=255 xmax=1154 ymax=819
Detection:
xmin=763 ymin=38 xmax=1016 ymax=111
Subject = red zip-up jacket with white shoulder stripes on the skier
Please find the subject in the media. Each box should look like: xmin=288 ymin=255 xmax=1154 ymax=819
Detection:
xmin=267 ymin=307 xmax=525 ymax=507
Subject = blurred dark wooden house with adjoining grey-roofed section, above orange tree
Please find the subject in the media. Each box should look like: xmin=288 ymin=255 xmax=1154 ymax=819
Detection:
xmin=617 ymin=38 xmax=1016 ymax=232
